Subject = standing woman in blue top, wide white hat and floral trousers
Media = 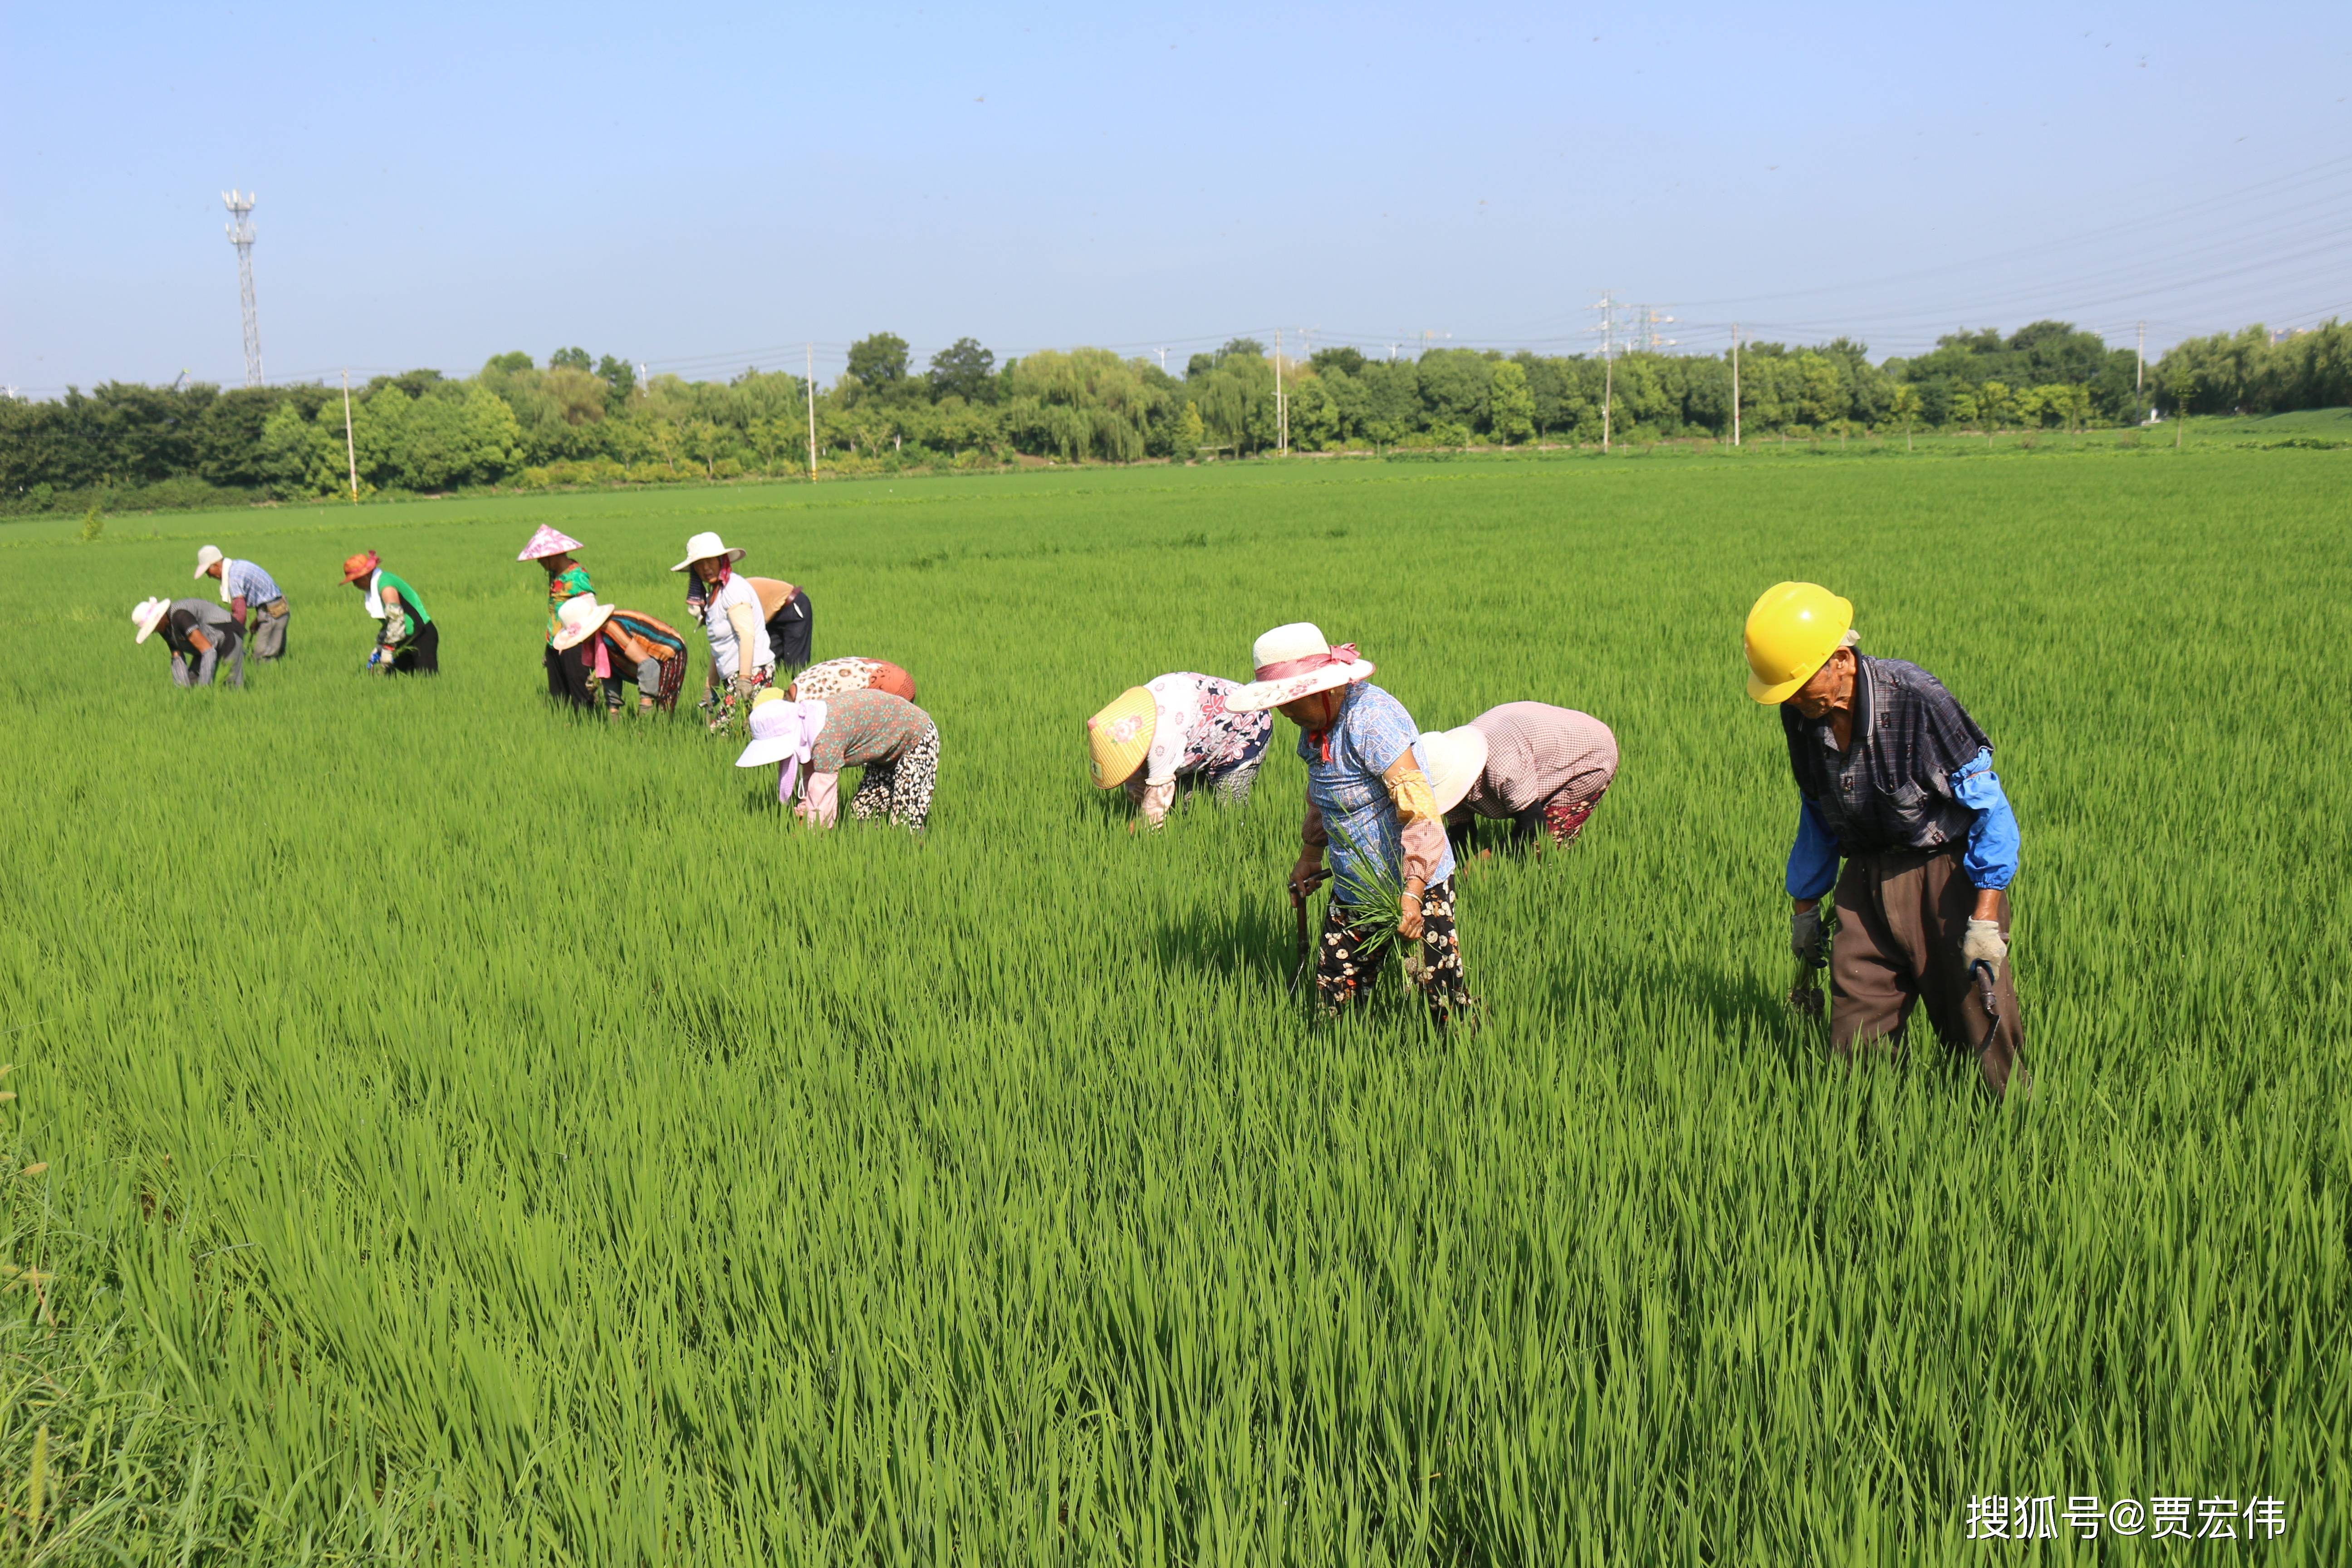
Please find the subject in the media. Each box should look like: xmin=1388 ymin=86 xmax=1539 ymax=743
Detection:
xmin=1225 ymin=621 xmax=1472 ymax=1025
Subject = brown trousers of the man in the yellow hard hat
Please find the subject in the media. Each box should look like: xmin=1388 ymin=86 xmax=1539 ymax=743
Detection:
xmin=1830 ymin=851 xmax=2025 ymax=1096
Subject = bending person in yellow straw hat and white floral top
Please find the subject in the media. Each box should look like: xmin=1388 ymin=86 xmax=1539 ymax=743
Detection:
xmin=1087 ymin=675 xmax=1275 ymax=828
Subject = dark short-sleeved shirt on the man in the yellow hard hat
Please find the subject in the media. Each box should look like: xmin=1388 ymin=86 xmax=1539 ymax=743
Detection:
xmin=1780 ymin=656 xmax=1992 ymax=860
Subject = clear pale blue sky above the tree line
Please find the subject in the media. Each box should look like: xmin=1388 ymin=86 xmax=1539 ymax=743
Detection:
xmin=0 ymin=0 xmax=2352 ymax=395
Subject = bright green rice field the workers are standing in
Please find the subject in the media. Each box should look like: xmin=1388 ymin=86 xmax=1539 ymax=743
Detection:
xmin=0 ymin=449 xmax=2352 ymax=1566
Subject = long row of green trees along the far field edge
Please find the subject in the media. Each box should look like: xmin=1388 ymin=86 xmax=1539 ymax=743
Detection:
xmin=0 ymin=320 xmax=2352 ymax=510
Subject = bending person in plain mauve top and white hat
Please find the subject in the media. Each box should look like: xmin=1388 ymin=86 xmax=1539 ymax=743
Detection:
xmin=1421 ymin=703 xmax=1618 ymax=846
